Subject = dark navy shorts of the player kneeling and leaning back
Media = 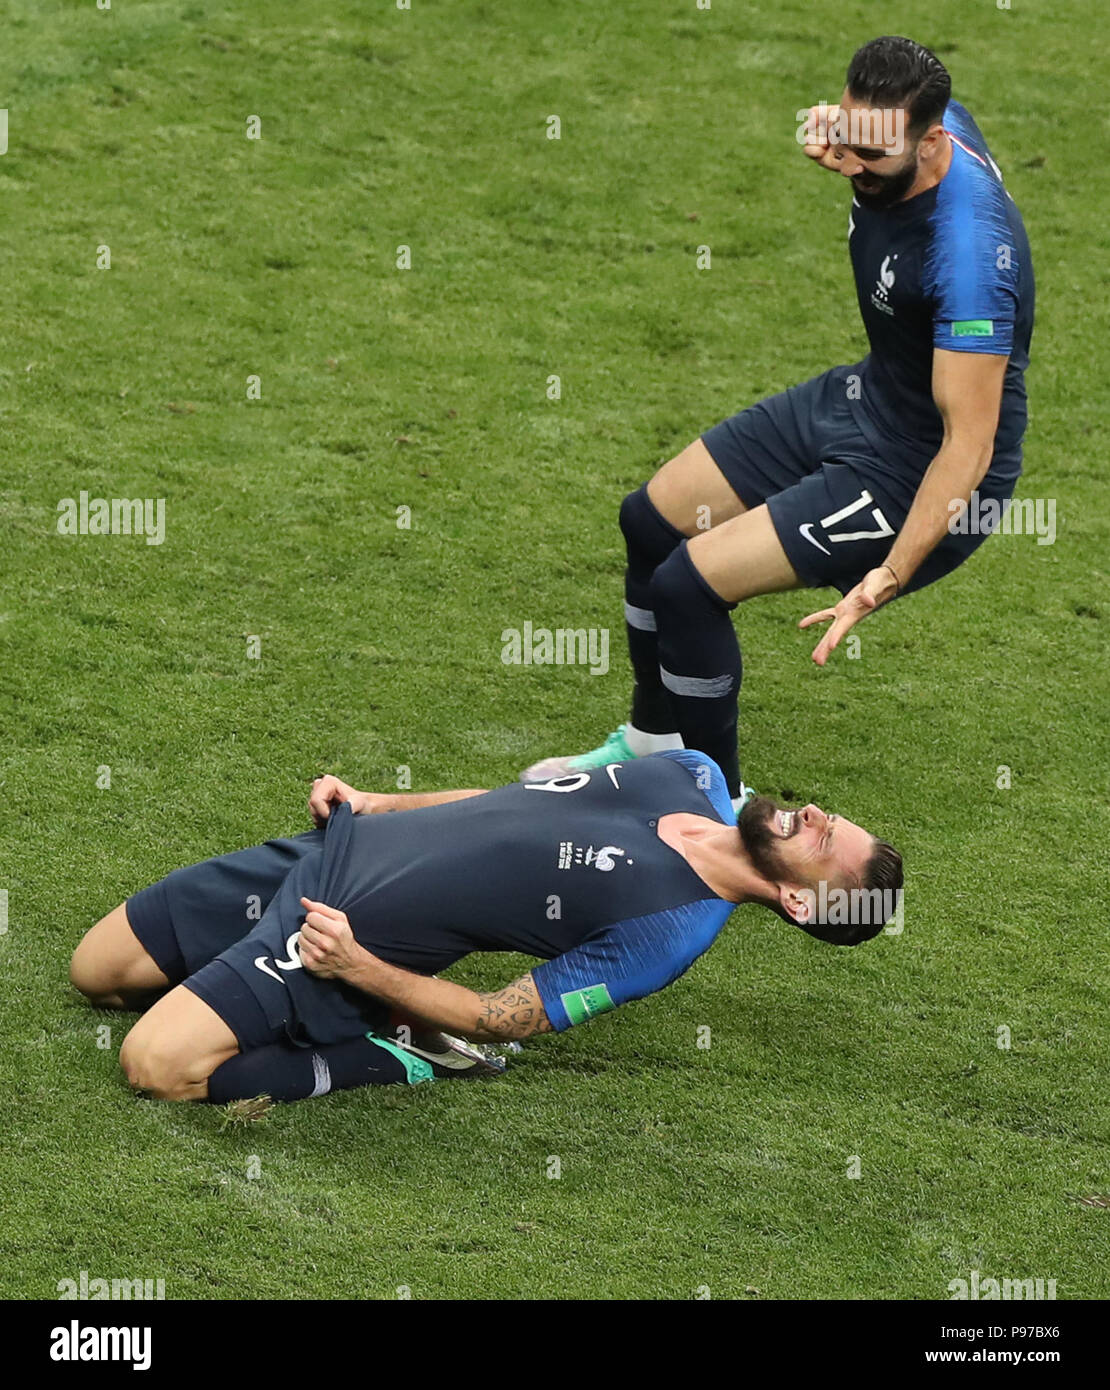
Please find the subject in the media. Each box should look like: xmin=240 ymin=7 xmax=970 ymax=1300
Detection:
xmin=126 ymin=830 xmax=390 ymax=1052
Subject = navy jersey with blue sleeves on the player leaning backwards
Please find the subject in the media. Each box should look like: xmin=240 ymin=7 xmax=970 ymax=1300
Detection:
xmin=308 ymin=751 xmax=736 ymax=1031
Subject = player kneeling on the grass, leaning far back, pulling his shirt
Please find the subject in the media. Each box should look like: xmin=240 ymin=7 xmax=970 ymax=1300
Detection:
xmin=69 ymin=751 xmax=902 ymax=1101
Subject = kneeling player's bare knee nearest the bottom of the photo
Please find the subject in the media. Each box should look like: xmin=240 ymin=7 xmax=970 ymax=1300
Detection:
xmin=119 ymin=984 xmax=239 ymax=1101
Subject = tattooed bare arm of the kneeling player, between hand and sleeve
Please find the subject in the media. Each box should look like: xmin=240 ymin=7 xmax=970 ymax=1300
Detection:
xmin=342 ymin=948 xmax=552 ymax=1043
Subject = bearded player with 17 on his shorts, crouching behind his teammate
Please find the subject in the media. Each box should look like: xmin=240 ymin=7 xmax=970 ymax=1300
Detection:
xmin=522 ymin=38 xmax=1034 ymax=798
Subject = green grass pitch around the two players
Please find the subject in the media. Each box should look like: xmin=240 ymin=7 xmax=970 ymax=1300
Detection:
xmin=0 ymin=0 xmax=1110 ymax=1300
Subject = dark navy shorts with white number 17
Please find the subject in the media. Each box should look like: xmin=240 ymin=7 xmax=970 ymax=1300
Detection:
xmin=702 ymin=366 xmax=1017 ymax=594
